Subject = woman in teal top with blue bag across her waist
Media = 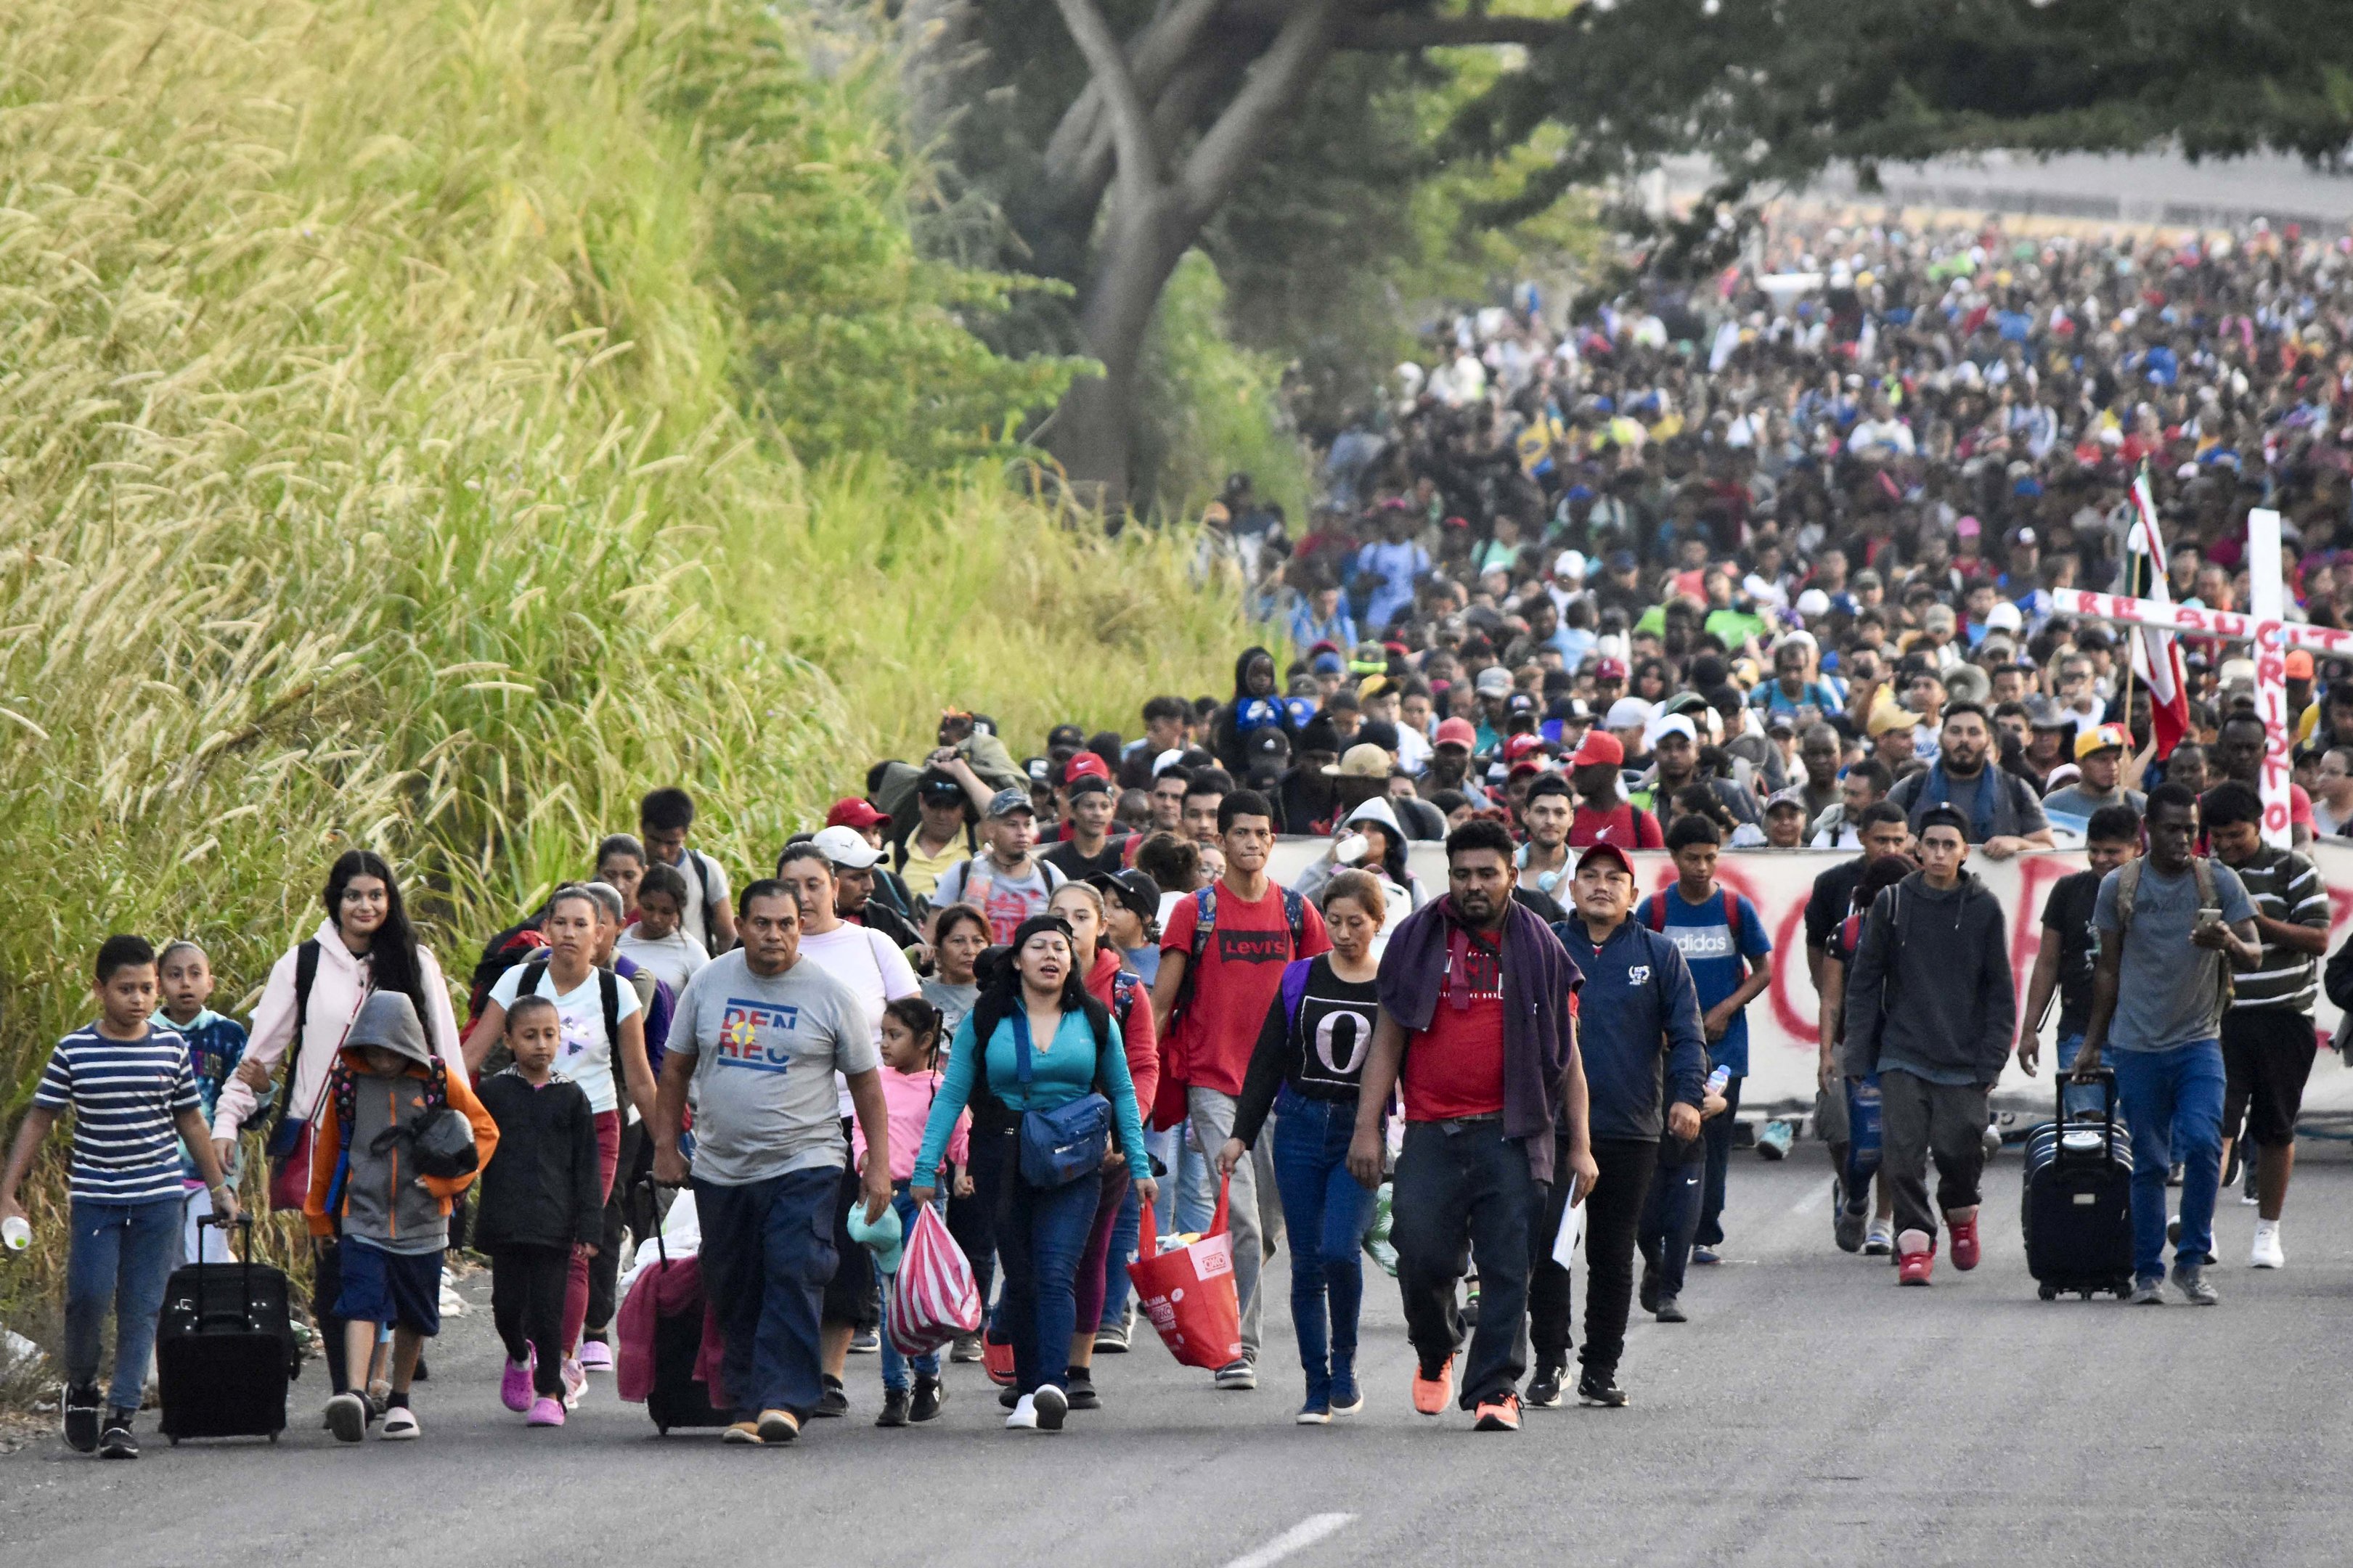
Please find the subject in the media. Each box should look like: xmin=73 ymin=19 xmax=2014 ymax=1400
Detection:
xmin=908 ymin=916 xmax=1160 ymax=1432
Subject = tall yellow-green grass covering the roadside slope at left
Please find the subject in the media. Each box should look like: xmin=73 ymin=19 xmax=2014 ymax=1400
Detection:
xmin=0 ymin=0 xmax=1236 ymax=1299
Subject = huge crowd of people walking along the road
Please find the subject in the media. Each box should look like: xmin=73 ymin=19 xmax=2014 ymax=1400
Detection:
xmin=0 ymin=207 xmax=2353 ymax=1458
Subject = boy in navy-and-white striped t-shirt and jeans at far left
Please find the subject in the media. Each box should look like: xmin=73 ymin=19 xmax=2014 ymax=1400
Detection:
xmin=0 ymin=937 xmax=237 ymax=1460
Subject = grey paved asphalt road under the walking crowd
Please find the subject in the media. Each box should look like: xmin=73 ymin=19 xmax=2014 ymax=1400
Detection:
xmin=0 ymin=1144 xmax=2353 ymax=1568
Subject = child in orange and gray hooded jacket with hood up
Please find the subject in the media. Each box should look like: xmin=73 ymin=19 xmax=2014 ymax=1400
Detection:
xmin=303 ymin=991 xmax=499 ymax=1443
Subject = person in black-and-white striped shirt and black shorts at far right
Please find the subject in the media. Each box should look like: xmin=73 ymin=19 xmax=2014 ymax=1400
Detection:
xmin=2200 ymin=780 xmax=2330 ymax=1269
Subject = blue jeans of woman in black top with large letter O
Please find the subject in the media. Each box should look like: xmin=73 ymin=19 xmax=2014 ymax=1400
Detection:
xmin=1276 ymin=1085 xmax=1372 ymax=1401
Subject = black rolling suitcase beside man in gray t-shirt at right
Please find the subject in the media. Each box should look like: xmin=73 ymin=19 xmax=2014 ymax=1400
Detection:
xmin=2019 ymin=1069 xmax=2132 ymax=1302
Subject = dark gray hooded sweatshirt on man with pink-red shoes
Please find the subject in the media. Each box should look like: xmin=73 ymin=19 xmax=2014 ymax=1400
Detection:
xmin=1840 ymin=871 xmax=2019 ymax=1085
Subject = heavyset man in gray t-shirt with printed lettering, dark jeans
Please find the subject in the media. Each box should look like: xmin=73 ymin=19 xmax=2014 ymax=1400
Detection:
xmin=654 ymin=881 xmax=889 ymax=1443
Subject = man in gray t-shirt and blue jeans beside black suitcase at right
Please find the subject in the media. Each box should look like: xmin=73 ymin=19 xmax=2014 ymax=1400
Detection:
xmin=2076 ymin=784 xmax=2262 ymax=1307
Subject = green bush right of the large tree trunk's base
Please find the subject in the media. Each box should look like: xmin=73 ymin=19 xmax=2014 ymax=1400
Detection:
xmin=1136 ymin=250 xmax=1310 ymax=527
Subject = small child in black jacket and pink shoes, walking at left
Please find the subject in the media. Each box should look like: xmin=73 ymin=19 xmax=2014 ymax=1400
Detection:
xmin=473 ymin=996 xmax=605 ymax=1426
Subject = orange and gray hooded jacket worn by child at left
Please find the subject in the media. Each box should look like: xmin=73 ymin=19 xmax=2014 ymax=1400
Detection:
xmin=303 ymin=991 xmax=499 ymax=1252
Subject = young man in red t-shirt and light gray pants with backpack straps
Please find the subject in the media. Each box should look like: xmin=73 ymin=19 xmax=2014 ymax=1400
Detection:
xmin=1153 ymin=788 xmax=1332 ymax=1389
